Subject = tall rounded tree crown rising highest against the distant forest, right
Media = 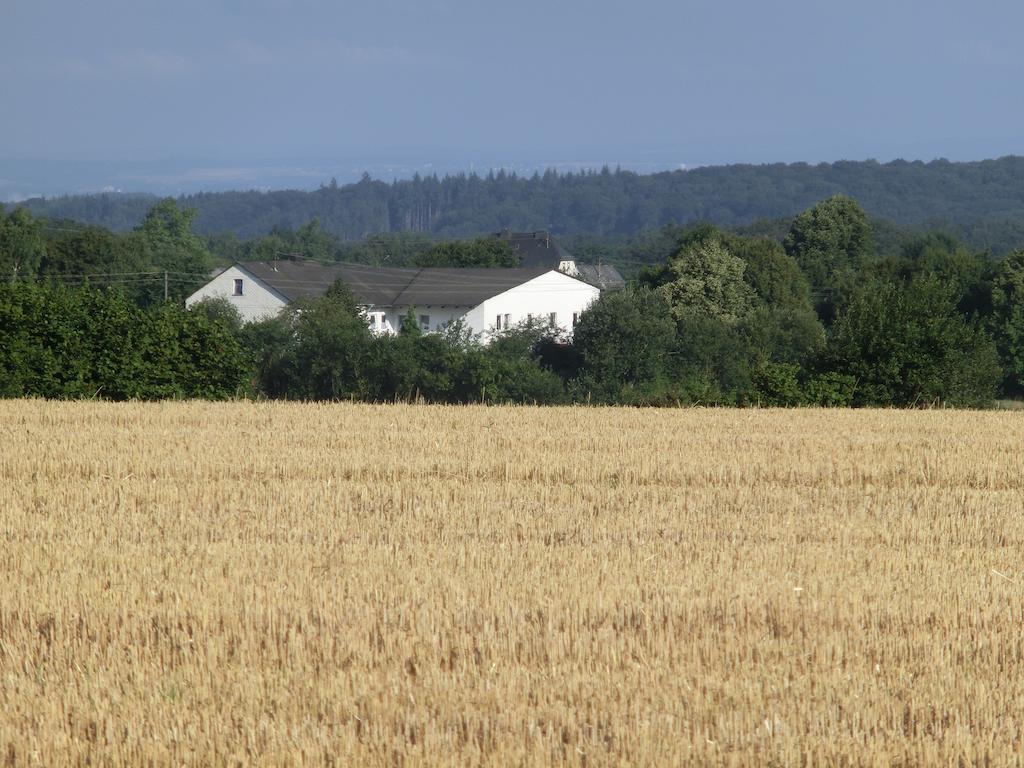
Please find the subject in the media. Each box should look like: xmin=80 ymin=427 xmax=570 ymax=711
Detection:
xmin=783 ymin=195 xmax=874 ymax=289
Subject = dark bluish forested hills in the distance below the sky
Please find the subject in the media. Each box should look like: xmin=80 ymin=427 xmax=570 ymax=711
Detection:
xmin=12 ymin=157 xmax=1024 ymax=255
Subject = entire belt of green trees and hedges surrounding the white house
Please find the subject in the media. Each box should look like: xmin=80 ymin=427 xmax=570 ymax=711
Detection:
xmin=8 ymin=196 xmax=1024 ymax=406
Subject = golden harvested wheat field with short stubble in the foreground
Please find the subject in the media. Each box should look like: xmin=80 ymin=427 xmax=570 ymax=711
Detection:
xmin=0 ymin=401 xmax=1024 ymax=766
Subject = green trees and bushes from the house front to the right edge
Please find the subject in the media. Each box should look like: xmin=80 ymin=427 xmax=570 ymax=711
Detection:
xmin=216 ymin=197 xmax=1007 ymax=407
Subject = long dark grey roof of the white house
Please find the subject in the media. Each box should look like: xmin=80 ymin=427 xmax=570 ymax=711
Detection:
xmin=239 ymin=260 xmax=552 ymax=306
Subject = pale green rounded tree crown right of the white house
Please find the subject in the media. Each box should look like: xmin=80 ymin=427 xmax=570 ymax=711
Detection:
xmin=657 ymin=240 xmax=754 ymax=324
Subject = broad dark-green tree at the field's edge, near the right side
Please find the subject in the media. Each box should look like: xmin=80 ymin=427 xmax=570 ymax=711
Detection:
xmin=822 ymin=278 xmax=1000 ymax=406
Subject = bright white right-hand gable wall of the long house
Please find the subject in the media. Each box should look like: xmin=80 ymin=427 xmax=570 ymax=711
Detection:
xmin=466 ymin=271 xmax=601 ymax=339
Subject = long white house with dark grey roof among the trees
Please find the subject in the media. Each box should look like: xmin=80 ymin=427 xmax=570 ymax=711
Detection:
xmin=185 ymin=261 xmax=601 ymax=340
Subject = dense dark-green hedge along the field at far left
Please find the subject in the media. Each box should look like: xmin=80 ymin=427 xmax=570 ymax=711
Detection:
xmin=0 ymin=284 xmax=248 ymax=399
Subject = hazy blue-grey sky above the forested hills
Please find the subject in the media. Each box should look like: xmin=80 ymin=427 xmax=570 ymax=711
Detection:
xmin=0 ymin=0 xmax=1024 ymax=199
